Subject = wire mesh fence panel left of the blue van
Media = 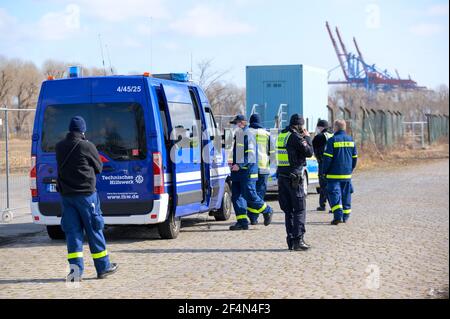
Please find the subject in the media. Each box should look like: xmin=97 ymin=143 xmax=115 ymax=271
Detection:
xmin=0 ymin=107 xmax=35 ymax=222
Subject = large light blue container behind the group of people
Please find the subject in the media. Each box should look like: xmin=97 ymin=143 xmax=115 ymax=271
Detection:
xmin=247 ymin=65 xmax=328 ymax=131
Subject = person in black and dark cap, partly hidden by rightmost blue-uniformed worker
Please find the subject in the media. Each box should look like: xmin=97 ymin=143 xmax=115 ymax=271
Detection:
xmin=313 ymin=120 xmax=333 ymax=212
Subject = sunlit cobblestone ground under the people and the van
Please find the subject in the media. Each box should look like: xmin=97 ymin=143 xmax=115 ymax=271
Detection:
xmin=0 ymin=160 xmax=449 ymax=298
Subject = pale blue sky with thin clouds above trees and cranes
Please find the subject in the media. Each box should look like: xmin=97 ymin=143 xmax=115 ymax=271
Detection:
xmin=0 ymin=0 xmax=449 ymax=88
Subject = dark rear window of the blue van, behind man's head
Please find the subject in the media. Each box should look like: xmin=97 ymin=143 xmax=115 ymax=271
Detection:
xmin=42 ymin=103 xmax=147 ymax=161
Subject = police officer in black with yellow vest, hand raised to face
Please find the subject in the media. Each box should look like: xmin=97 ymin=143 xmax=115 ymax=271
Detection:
xmin=277 ymin=114 xmax=313 ymax=251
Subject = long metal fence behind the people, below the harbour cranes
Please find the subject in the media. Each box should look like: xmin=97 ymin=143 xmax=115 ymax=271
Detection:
xmin=328 ymin=107 xmax=449 ymax=150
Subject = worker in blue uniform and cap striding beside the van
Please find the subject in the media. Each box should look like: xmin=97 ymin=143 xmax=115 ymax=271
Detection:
xmin=230 ymin=115 xmax=273 ymax=231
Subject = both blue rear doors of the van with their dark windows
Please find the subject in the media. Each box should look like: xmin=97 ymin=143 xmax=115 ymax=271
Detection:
xmin=38 ymin=79 xmax=154 ymax=216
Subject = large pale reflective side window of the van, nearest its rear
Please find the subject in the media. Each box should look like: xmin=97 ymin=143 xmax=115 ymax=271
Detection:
xmin=169 ymin=102 xmax=201 ymax=148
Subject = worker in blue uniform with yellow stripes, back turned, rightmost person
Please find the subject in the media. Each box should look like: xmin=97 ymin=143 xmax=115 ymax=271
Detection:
xmin=321 ymin=120 xmax=358 ymax=225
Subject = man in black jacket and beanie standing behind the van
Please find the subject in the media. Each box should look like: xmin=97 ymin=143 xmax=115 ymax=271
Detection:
xmin=56 ymin=116 xmax=118 ymax=281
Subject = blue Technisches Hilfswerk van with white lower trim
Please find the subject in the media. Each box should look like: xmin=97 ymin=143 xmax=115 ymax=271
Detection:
xmin=30 ymin=73 xmax=232 ymax=239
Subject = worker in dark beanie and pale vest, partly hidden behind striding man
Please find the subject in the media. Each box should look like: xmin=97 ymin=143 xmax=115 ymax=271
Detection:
xmin=248 ymin=114 xmax=275 ymax=225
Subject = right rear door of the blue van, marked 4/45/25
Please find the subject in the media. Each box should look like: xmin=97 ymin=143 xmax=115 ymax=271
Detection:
xmin=88 ymin=78 xmax=155 ymax=216
